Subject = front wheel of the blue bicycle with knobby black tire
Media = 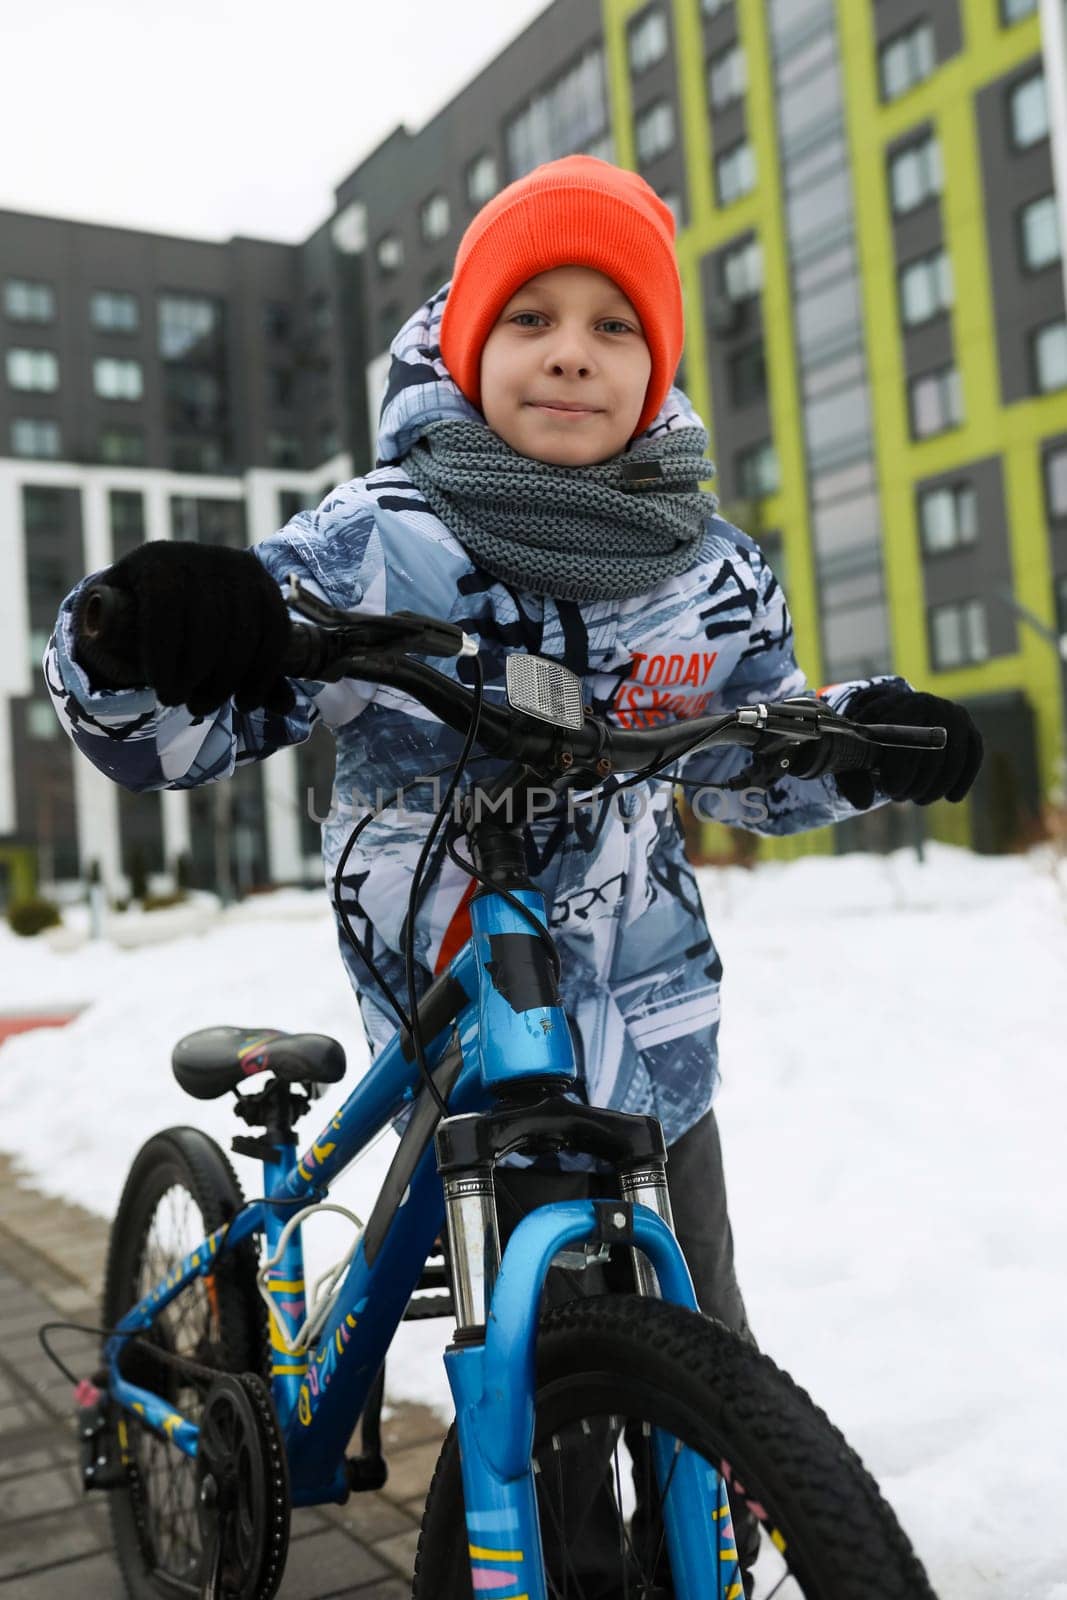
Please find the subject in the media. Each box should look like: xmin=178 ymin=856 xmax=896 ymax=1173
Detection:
xmin=413 ymin=1294 xmax=934 ymax=1600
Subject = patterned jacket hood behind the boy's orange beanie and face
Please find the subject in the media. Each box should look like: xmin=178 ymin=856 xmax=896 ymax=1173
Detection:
xmin=376 ymin=283 xmax=716 ymax=467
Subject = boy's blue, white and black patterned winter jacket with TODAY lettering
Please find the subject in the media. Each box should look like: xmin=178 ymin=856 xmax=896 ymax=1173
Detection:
xmin=45 ymin=291 xmax=902 ymax=1142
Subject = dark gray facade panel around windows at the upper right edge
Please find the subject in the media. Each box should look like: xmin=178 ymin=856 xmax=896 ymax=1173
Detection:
xmin=974 ymin=56 xmax=1064 ymax=405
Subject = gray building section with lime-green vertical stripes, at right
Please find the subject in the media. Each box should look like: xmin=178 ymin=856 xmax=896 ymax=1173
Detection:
xmin=605 ymin=0 xmax=1067 ymax=848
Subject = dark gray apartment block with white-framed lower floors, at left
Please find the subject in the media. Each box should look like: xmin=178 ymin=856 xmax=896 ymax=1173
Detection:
xmin=0 ymin=211 xmax=352 ymax=888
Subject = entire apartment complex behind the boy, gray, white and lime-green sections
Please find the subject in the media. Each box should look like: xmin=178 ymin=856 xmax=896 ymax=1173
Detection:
xmin=0 ymin=0 xmax=1067 ymax=902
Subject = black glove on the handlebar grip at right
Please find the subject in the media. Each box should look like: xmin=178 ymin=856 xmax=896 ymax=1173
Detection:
xmin=833 ymin=683 xmax=982 ymax=811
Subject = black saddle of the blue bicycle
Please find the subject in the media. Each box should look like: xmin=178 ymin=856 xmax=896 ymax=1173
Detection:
xmin=171 ymin=1027 xmax=346 ymax=1099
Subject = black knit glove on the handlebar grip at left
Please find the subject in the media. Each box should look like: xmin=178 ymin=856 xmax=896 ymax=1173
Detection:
xmin=74 ymin=539 xmax=296 ymax=717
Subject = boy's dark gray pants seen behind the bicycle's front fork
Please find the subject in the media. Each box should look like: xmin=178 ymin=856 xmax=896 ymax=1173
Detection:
xmin=496 ymin=1110 xmax=758 ymax=1597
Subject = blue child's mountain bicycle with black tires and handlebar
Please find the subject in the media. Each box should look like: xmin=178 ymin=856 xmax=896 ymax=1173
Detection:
xmin=68 ymin=582 xmax=944 ymax=1600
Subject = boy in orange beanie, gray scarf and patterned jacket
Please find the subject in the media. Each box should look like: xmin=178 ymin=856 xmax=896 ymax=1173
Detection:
xmin=46 ymin=155 xmax=981 ymax=1580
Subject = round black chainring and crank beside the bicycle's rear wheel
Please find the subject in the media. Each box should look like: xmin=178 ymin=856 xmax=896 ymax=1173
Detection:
xmin=197 ymin=1373 xmax=290 ymax=1600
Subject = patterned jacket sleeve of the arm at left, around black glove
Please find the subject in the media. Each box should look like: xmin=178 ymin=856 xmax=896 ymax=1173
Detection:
xmin=43 ymin=504 xmax=381 ymax=794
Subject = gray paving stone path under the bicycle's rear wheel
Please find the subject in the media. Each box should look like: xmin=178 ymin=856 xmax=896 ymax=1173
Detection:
xmin=0 ymin=1154 xmax=442 ymax=1600
